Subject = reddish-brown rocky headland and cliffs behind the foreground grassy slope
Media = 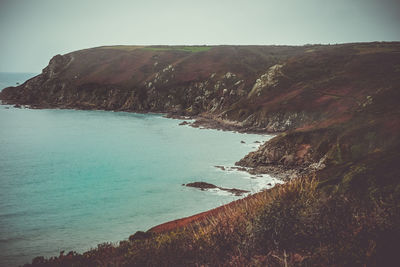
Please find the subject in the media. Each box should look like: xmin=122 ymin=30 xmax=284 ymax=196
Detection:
xmin=0 ymin=43 xmax=400 ymax=195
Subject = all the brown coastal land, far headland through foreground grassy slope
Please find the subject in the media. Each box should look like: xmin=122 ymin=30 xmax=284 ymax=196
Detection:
xmin=0 ymin=42 xmax=400 ymax=266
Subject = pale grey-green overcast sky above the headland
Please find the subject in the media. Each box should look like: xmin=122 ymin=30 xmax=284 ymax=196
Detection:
xmin=0 ymin=0 xmax=400 ymax=73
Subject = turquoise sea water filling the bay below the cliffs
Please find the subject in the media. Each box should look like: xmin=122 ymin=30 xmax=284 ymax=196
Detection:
xmin=0 ymin=73 xmax=279 ymax=266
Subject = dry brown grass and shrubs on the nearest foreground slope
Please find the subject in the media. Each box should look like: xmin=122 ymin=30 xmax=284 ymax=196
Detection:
xmin=24 ymin=178 xmax=400 ymax=266
